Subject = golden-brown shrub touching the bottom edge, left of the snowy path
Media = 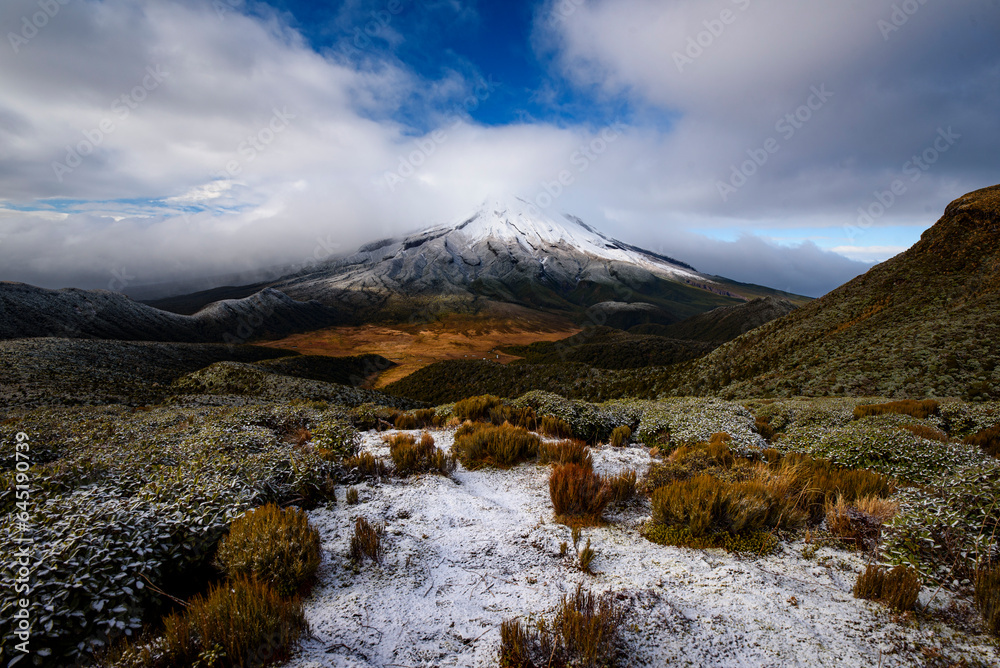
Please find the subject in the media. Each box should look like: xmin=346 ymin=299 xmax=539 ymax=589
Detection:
xmin=105 ymin=577 xmax=306 ymax=668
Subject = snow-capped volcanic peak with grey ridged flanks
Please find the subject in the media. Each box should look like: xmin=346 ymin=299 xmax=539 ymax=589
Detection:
xmin=271 ymin=198 xmax=796 ymax=323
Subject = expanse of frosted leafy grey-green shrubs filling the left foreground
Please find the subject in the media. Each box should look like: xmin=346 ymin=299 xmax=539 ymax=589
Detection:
xmin=0 ymin=407 xmax=357 ymax=665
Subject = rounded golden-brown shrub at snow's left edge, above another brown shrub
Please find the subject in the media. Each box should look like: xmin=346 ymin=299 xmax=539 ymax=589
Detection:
xmin=216 ymin=504 xmax=320 ymax=596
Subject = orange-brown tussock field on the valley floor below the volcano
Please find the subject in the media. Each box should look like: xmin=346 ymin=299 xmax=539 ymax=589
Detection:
xmin=261 ymin=316 xmax=580 ymax=388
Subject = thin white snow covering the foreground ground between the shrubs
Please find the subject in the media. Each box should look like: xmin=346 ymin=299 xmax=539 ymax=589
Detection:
xmin=288 ymin=431 xmax=1000 ymax=668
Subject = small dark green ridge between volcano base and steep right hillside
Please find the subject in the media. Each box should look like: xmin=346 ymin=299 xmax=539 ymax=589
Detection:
xmin=629 ymin=297 xmax=796 ymax=345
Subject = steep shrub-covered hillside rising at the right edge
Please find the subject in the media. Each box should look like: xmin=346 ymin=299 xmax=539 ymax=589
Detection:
xmin=664 ymin=186 xmax=1000 ymax=398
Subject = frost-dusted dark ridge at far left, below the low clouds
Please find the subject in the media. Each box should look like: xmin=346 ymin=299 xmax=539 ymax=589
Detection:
xmin=0 ymin=283 xmax=338 ymax=343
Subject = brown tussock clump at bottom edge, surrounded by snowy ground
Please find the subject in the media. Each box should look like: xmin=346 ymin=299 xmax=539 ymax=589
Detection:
xmin=499 ymin=586 xmax=625 ymax=668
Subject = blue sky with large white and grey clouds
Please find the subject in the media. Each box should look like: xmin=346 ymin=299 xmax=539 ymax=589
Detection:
xmin=0 ymin=0 xmax=1000 ymax=295
